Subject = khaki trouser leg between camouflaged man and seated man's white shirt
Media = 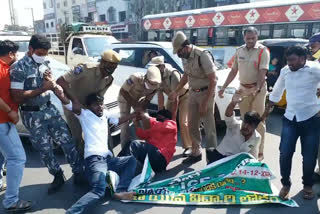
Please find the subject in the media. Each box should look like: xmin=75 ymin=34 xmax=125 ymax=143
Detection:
xmin=63 ymin=107 xmax=84 ymax=157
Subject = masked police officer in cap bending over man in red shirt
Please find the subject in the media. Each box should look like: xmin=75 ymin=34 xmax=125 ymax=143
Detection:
xmin=118 ymin=66 xmax=161 ymax=148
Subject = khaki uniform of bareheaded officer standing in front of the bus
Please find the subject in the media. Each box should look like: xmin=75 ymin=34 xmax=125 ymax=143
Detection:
xmin=232 ymin=43 xmax=270 ymax=153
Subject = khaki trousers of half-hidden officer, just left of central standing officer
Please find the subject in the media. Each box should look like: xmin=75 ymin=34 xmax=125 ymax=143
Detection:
xmin=166 ymin=93 xmax=192 ymax=149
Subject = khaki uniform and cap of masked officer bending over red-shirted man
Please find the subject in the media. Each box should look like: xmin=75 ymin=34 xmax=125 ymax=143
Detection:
xmin=118 ymin=66 xmax=161 ymax=148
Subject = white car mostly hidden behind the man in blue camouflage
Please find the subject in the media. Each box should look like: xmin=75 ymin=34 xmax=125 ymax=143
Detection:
xmin=0 ymin=36 xmax=120 ymax=136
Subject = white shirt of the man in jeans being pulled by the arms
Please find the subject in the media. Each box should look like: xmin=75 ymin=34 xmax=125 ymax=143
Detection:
xmin=65 ymin=101 xmax=119 ymax=158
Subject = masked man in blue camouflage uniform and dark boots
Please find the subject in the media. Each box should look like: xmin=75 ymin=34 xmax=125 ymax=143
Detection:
xmin=10 ymin=35 xmax=82 ymax=194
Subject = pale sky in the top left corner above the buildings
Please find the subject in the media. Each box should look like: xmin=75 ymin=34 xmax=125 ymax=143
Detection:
xmin=0 ymin=0 xmax=43 ymax=30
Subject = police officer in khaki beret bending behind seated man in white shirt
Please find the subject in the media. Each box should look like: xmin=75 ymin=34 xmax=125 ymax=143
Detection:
xmin=57 ymin=50 xmax=121 ymax=154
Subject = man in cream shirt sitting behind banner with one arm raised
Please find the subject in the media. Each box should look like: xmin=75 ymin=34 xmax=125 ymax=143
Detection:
xmin=207 ymin=91 xmax=262 ymax=164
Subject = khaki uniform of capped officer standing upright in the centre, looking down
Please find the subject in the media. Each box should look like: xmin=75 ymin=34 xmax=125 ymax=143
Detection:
xmin=183 ymin=46 xmax=217 ymax=149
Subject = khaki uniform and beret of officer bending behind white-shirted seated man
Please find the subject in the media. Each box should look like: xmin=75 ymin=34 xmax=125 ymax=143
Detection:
xmin=63 ymin=50 xmax=121 ymax=153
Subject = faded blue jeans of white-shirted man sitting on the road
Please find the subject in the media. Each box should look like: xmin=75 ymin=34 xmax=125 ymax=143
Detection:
xmin=67 ymin=155 xmax=136 ymax=214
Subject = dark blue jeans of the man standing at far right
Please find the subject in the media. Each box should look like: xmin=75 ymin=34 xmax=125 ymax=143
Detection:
xmin=280 ymin=115 xmax=320 ymax=186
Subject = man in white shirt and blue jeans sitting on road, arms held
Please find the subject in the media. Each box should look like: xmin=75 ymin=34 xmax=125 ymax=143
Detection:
xmin=55 ymin=88 xmax=136 ymax=214
